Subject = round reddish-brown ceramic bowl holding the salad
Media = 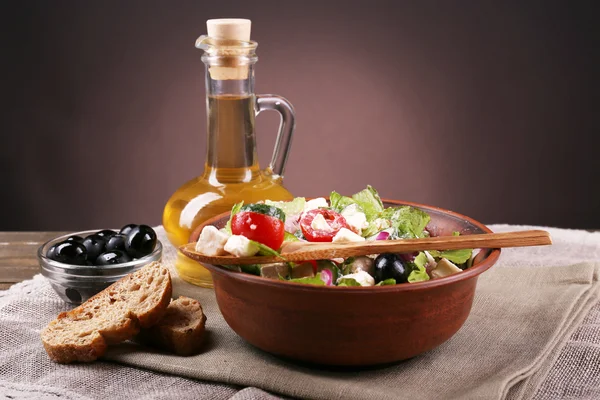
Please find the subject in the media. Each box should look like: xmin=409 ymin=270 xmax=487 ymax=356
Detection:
xmin=190 ymin=200 xmax=500 ymax=366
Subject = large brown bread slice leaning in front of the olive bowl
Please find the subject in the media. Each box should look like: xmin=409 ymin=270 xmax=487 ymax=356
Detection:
xmin=41 ymin=262 xmax=173 ymax=364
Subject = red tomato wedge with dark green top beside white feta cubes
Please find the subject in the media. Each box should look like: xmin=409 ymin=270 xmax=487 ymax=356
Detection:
xmin=231 ymin=211 xmax=285 ymax=250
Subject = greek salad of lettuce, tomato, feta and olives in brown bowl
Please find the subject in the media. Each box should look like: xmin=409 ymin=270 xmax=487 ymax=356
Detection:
xmin=195 ymin=186 xmax=473 ymax=286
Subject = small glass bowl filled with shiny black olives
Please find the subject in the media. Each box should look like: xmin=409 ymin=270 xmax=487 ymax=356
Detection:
xmin=38 ymin=224 xmax=162 ymax=304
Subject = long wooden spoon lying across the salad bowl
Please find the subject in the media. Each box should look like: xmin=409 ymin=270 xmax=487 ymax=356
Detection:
xmin=179 ymin=230 xmax=552 ymax=265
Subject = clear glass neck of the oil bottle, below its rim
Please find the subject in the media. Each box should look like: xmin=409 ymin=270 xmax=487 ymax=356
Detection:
xmin=204 ymin=63 xmax=259 ymax=183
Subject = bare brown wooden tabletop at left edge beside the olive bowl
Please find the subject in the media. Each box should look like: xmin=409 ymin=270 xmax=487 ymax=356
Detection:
xmin=0 ymin=232 xmax=66 ymax=290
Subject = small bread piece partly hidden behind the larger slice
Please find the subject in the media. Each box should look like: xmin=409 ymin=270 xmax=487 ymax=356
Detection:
xmin=137 ymin=296 xmax=206 ymax=356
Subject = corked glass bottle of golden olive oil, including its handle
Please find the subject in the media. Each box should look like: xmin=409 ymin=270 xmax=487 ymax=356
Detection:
xmin=163 ymin=20 xmax=294 ymax=287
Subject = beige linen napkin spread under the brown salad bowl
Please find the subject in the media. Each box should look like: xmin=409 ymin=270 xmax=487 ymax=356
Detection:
xmin=105 ymin=263 xmax=600 ymax=399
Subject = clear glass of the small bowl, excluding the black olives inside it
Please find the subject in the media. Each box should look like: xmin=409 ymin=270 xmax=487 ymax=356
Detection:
xmin=37 ymin=230 xmax=162 ymax=305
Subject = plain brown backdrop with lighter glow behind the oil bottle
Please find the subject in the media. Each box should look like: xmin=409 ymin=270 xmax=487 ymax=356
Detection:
xmin=0 ymin=0 xmax=600 ymax=230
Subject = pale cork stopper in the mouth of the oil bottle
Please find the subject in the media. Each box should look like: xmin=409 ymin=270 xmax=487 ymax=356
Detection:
xmin=206 ymin=18 xmax=252 ymax=81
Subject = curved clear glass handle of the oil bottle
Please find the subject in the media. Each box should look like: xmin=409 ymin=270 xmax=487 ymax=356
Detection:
xmin=256 ymin=94 xmax=296 ymax=179
